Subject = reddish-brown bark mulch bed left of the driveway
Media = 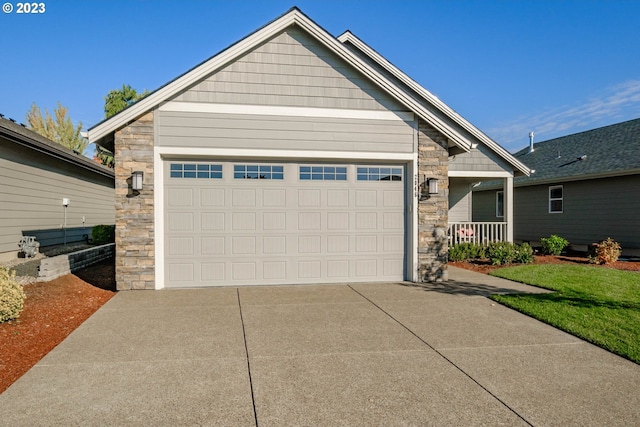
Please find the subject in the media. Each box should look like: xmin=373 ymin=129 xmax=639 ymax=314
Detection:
xmin=0 ymin=260 xmax=115 ymax=393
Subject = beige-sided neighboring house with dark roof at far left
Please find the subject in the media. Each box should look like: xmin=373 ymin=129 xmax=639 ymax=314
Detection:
xmin=0 ymin=118 xmax=115 ymax=261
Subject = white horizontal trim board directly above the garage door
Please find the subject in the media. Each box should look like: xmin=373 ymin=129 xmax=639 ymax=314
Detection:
xmin=154 ymin=147 xmax=414 ymax=162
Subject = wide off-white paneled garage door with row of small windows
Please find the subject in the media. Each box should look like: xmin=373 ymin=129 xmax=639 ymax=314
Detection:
xmin=165 ymin=161 xmax=406 ymax=287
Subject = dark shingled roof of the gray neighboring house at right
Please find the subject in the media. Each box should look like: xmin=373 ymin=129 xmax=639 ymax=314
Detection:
xmin=476 ymin=118 xmax=640 ymax=190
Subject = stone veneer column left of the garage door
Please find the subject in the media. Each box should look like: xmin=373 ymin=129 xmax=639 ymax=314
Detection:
xmin=114 ymin=113 xmax=155 ymax=290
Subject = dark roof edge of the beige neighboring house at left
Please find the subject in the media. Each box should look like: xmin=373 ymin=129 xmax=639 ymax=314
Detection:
xmin=0 ymin=118 xmax=114 ymax=179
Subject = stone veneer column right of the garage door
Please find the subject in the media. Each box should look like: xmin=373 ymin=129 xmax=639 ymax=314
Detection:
xmin=418 ymin=120 xmax=449 ymax=282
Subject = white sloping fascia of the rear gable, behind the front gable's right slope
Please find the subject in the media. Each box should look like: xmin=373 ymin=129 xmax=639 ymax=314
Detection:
xmin=338 ymin=31 xmax=531 ymax=176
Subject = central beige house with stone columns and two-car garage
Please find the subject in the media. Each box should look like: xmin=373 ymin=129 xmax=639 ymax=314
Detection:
xmin=89 ymin=8 xmax=529 ymax=289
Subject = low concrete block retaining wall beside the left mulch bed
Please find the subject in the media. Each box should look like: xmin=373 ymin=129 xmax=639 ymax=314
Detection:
xmin=38 ymin=243 xmax=116 ymax=282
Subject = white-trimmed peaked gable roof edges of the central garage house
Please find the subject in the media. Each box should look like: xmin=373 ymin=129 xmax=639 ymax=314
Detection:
xmin=88 ymin=7 xmax=530 ymax=175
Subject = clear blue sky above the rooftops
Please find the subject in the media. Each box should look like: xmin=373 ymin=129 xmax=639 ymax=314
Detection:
xmin=0 ymin=0 xmax=640 ymax=152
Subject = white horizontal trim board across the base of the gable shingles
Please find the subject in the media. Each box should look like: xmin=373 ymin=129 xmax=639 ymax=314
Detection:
xmin=158 ymin=101 xmax=414 ymax=122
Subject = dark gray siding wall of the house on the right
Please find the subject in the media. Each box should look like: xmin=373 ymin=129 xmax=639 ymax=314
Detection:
xmin=473 ymin=175 xmax=640 ymax=249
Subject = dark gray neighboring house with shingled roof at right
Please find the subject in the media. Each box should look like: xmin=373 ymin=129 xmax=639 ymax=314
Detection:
xmin=473 ymin=119 xmax=640 ymax=254
